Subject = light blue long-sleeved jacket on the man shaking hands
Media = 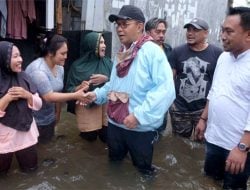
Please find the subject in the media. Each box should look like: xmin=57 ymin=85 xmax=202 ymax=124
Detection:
xmin=95 ymin=41 xmax=175 ymax=131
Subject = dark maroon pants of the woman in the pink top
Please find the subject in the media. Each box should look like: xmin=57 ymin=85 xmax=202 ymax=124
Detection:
xmin=0 ymin=145 xmax=37 ymax=174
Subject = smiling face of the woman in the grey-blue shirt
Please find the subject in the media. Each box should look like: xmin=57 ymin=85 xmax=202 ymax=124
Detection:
xmin=50 ymin=43 xmax=68 ymax=66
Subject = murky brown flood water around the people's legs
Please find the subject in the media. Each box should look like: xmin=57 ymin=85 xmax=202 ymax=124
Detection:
xmin=0 ymin=108 xmax=248 ymax=190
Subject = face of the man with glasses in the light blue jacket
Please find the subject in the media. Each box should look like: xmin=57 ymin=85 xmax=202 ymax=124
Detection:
xmin=115 ymin=19 xmax=144 ymax=48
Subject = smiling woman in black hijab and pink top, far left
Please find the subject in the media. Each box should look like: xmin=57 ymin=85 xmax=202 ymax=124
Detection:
xmin=0 ymin=41 xmax=42 ymax=174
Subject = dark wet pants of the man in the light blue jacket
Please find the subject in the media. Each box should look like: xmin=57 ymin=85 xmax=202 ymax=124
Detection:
xmin=107 ymin=123 xmax=158 ymax=173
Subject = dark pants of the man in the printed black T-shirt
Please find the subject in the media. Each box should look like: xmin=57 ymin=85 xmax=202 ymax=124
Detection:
xmin=170 ymin=110 xmax=202 ymax=137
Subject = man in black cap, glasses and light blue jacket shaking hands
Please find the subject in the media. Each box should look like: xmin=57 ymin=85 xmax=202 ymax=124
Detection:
xmin=83 ymin=5 xmax=175 ymax=173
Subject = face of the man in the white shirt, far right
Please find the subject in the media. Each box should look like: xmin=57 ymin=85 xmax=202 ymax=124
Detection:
xmin=221 ymin=15 xmax=250 ymax=56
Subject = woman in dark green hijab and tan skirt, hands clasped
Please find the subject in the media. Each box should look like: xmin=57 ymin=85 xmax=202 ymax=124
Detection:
xmin=66 ymin=32 xmax=112 ymax=142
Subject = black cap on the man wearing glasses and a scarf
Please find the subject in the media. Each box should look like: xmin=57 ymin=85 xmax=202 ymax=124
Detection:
xmin=109 ymin=5 xmax=145 ymax=23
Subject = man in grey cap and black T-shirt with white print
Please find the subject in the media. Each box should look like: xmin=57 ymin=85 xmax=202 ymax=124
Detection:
xmin=169 ymin=18 xmax=222 ymax=137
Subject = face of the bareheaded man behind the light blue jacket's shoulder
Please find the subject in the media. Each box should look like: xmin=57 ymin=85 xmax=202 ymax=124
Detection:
xmin=148 ymin=23 xmax=167 ymax=46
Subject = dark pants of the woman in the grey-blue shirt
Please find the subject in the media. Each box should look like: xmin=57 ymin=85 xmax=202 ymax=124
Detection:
xmin=37 ymin=121 xmax=56 ymax=143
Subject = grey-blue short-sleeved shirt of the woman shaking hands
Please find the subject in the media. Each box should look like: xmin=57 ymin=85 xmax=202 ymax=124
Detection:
xmin=25 ymin=58 xmax=64 ymax=126
